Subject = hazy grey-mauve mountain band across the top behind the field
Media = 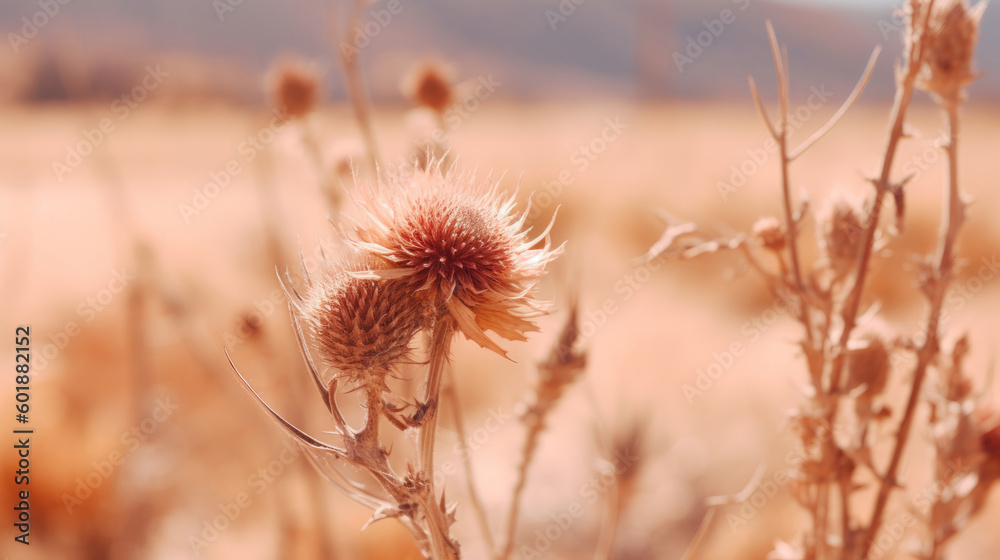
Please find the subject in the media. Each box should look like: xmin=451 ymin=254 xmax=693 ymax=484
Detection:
xmin=0 ymin=0 xmax=1000 ymax=102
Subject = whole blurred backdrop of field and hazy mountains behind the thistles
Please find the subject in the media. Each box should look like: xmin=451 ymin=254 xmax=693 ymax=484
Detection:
xmin=0 ymin=0 xmax=1000 ymax=559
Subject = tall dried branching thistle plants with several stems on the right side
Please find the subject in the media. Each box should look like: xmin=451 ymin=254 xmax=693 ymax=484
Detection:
xmin=648 ymin=0 xmax=996 ymax=560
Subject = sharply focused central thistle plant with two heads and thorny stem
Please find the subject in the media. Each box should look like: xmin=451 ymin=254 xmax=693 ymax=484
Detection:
xmin=237 ymin=163 xmax=572 ymax=559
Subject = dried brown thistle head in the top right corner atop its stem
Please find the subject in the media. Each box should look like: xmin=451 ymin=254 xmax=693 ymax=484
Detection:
xmin=916 ymin=0 xmax=986 ymax=102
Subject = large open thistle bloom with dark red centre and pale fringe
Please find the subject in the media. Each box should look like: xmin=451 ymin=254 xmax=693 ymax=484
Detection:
xmin=347 ymin=161 xmax=562 ymax=356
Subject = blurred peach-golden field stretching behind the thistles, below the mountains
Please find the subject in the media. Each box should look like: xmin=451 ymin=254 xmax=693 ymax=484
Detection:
xmin=0 ymin=96 xmax=1000 ymax=559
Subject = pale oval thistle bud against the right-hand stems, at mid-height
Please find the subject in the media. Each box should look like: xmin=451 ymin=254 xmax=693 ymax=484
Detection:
xmin=816 ymin=192 xmax=864 ymax=275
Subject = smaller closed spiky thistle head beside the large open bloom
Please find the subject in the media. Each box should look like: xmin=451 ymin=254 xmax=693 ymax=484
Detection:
xmin=300 ymin=255 xmax=426 ymax=387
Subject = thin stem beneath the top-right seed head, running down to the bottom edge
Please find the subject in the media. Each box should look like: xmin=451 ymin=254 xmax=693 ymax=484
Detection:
xmin=862 ymin=99 xmax=965 ymax=556
